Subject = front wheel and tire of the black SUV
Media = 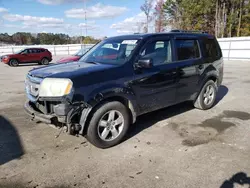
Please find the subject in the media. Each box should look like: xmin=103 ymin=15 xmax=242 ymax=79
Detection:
xmin=86 ymin=101 xmax=129 ymax=149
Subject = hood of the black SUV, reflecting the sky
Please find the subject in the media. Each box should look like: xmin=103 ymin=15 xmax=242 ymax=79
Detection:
xmin=29 ymin=62 xmax=115 ymax=78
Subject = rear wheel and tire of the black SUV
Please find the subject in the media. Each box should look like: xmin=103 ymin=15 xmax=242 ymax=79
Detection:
xmin=194 ymin=80 xmax=218 ymax=110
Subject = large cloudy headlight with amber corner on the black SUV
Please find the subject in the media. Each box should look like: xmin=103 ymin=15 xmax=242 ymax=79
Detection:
xmin=39 ymin=78 xmax=73 ymax=97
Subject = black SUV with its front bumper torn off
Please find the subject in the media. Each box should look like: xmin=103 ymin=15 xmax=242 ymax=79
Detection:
xmin=25 ymin=31 xmax=223 ymax=148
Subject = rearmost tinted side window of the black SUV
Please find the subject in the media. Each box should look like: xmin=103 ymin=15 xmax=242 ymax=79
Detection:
xmin=203 ymin=39 xmax=220 ymax=57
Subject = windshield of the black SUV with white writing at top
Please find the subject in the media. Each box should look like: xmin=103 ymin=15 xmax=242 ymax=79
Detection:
xmin=80 ymin=39 xmax=139 ymax=65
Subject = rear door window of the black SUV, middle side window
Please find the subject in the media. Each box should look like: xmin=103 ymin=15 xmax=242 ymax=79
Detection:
xmin=175 ymin=39 xmax=200 ymax=61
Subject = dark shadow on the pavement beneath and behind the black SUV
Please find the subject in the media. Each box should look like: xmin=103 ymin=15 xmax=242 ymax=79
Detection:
xmin=125 ymin=85 xmax=228 ymax=140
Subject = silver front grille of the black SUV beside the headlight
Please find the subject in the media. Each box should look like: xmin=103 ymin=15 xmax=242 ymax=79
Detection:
xmin=25 ymin=74 xmax=43 ymax=102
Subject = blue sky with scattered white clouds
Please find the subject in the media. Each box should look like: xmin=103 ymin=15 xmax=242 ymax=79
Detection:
xmin=0 ymin=0 xmax=157 ymax=38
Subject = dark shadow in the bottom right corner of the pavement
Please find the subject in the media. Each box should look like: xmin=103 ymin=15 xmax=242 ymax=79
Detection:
xmin=220 ymin=172 xmax=250 ymax=188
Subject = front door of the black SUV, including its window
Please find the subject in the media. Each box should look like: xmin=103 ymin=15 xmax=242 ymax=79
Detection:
xmin=132 ymin=37 xmax=177 ymax=114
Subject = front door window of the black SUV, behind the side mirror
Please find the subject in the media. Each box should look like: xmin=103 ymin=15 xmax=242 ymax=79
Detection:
xmin=140 ymin=40 xmax=172 ymax=66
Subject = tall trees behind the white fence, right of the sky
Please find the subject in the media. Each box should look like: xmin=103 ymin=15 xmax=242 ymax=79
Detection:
xmin=163 ymin=0 xmax=250 ymax=37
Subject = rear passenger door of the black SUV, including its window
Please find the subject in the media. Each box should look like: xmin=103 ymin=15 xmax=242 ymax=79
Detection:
xmin=174 ymin=36 xmax=204 ymax=102
